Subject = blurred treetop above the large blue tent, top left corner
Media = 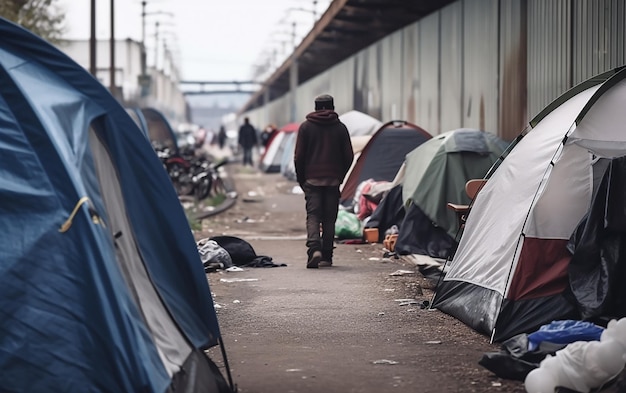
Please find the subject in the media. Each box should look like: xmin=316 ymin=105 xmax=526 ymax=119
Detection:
xmin=0 ymin=0 xmax=65 ymax=43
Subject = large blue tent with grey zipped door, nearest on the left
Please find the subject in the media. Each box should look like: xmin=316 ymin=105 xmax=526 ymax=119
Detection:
xmin=0 ymin=18 xmax=232 ymax=392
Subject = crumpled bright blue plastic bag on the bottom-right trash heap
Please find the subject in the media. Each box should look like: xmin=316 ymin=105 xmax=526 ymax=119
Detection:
xmin=528 ymin=320 xmax=604 ymax=351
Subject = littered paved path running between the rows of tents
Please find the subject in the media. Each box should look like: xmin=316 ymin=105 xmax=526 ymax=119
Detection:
xmin=195 ymin=156 xmax=525 ymax=393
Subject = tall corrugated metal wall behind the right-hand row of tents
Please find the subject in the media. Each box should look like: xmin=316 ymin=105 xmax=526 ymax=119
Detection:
xmin=248 ymin=0 xmax=626 ymax=140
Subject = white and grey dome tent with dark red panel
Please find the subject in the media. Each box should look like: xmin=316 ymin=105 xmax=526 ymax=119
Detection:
xmin=432 ymin=68 xmax=626 ymax=342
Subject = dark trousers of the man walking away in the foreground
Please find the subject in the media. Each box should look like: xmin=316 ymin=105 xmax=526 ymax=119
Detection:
xmin=302 ymin=184 xmax=340 ymax=261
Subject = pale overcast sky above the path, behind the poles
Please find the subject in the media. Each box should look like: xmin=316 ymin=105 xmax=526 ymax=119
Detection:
xmin=57 ymin=0 xmax=331 ymax=81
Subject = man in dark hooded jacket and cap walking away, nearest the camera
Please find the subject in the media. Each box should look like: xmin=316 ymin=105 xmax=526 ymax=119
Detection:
xmin=294 ymin=94 xmax=354 ymax=269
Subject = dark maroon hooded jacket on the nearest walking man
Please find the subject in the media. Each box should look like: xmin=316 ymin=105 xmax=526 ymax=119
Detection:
xmin=294 ymin=109 xmax=354 ymax=184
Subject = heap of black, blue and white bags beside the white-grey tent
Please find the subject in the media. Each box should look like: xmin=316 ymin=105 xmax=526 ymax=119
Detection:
xmin=479 ymin=318 xmax=626 ymax=393
